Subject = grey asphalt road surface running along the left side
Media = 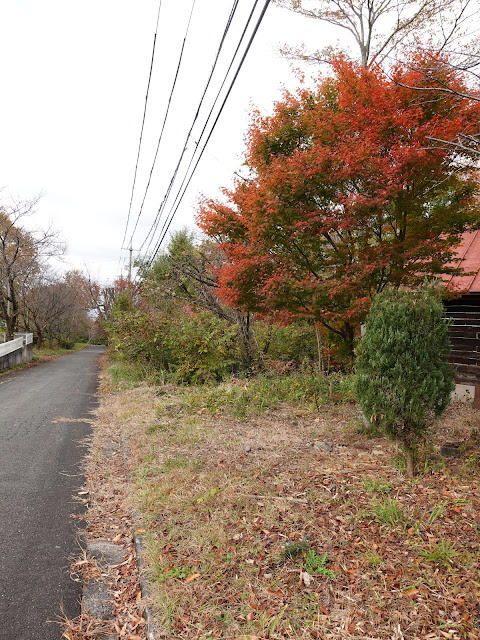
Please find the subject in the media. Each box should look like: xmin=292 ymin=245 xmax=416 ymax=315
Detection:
xmin=0 ymin=347 xmax=103 ymax=640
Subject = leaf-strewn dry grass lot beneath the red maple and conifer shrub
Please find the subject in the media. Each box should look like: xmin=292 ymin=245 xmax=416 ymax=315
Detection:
xmin=92 ymin=376 xmax=480 ymax=640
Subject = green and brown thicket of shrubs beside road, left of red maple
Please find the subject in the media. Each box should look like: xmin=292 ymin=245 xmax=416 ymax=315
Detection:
xmin=103 ymin=230 xmax=342 ymax=383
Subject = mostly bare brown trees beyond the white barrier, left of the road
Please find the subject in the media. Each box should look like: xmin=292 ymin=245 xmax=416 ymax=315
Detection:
xmin=0 ymin=198 xmax=98 ymax=348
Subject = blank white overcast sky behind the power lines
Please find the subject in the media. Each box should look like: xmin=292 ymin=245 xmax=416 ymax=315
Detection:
xmin=0 ymin=0 xmax=341 ymax=282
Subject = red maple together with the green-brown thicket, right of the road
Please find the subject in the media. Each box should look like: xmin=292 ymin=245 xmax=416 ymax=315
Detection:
xmin=106 ymin=53 xmax=480 ymax=382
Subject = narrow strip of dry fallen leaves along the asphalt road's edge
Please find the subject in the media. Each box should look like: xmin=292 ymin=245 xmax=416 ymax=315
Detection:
xmin=60 ymin=360 xmax=146 ymax=640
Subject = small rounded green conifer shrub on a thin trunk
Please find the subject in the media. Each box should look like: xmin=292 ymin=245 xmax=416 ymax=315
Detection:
xmin=355 ymin=286 xmax=455 ymax=476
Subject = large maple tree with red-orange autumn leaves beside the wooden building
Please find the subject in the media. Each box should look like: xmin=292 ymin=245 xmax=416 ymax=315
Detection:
xmin=198 ymin=58 xmax=480 ymax=349
